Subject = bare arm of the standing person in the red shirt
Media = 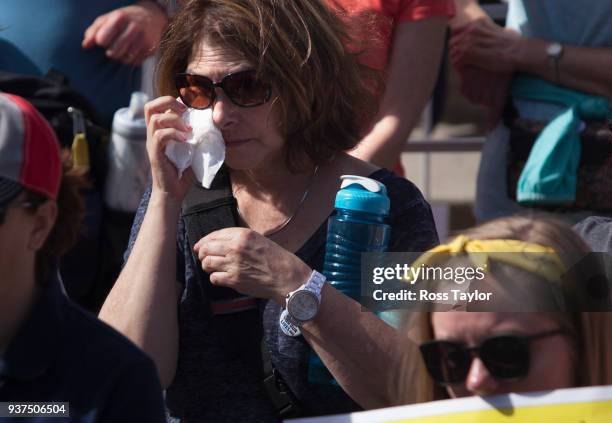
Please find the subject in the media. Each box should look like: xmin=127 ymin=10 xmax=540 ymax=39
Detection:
xmin=351 ymin=17 xmax=447 ymax=168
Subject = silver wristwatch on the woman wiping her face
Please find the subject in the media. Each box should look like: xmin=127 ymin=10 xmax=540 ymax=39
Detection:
xmin=279 ymin=270 xmax=325 ymax=336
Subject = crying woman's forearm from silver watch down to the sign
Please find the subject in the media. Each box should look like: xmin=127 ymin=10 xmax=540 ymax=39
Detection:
xmin=302 ymin=284 xmax=401 ymax=409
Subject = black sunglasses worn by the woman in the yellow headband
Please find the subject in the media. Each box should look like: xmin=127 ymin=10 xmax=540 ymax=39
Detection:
xmin=419 ymin=329 xmax=567 ymax=385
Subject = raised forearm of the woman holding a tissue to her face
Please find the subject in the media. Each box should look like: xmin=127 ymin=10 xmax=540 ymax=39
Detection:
xmin=99 ymin=194 xmax=180 ymax=387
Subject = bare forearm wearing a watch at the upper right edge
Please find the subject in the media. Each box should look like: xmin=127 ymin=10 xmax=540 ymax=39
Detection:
xmin=514 ymin=37 xmax=612 ymax=98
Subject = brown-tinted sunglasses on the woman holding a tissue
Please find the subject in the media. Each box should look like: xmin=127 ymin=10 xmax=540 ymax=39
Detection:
xmin=174 ymin=70 xmax=272 ymax=109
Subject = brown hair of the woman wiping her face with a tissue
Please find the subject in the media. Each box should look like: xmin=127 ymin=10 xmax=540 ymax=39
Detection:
xmin=157 ymin=0 xmax=380 ymax=169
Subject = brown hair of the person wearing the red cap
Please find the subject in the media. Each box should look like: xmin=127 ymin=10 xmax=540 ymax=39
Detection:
xmin=26 ymin=152 xmax=87 ymax=284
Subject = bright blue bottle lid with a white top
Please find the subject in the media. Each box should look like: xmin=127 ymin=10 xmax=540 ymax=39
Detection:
xmin=334 ymin=175 xmax=391 ymax=216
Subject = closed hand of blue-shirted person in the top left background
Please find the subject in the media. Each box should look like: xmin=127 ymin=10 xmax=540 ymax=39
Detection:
xmin=82 ymin=0 xmax=168 ymax=65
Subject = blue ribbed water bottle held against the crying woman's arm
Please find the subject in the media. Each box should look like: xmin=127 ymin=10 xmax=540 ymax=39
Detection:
xmin=308 ymin=175 xmax=391 ymax=384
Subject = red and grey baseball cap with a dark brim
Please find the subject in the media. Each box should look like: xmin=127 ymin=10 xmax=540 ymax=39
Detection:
xmin=0 ymin=93 xmax=62 ymax=205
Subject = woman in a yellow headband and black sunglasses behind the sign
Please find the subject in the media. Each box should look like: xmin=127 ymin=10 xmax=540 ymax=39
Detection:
xmin=399 ymin=217 xmax=612 ymax=402
